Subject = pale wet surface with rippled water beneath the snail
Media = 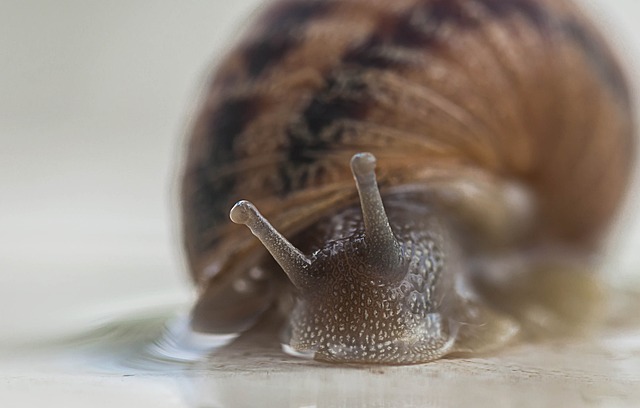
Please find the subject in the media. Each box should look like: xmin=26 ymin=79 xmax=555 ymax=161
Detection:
xmin=0 ymin=295 xmax=640 ymax=408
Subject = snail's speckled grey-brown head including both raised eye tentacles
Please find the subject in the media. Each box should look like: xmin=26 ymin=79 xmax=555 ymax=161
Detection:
xmin=230 ymin=153 xmax=455 ymax=364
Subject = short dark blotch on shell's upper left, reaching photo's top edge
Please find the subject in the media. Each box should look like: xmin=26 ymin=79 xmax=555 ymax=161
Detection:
xmin=243 ymin=0 xmax=332 ymax=78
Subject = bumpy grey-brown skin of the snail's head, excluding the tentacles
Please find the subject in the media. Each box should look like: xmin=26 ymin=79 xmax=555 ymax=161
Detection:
xmin=289 ymin=200 xmax=461 ymax=364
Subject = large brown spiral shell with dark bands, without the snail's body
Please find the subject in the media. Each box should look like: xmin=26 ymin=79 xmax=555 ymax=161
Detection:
xmin=182 ymin=0 xmax=635 ymax=361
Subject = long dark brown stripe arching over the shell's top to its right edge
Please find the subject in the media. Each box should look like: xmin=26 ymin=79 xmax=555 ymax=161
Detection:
xmin=280 ymin=0 xmax=629 ymax=190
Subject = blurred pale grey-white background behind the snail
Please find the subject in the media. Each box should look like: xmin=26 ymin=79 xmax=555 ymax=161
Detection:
xmin=0 ymin=0 xmax=640 ymax=346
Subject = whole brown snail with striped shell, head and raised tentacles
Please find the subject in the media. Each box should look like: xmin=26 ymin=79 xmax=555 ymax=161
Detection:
xmin=182 ymin=0 xmax=635 ymax=364
